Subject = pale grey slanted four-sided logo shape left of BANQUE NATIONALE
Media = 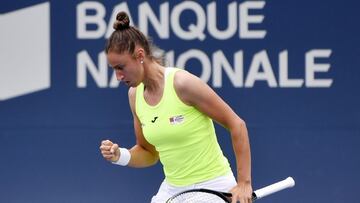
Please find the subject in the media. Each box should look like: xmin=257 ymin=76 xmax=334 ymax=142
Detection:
xmin=0 ymin=2 xmax=50 ymax=101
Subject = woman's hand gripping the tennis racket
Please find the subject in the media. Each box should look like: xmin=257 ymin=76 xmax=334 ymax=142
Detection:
xmin=230 ymin=182 xmax=252 ymax=203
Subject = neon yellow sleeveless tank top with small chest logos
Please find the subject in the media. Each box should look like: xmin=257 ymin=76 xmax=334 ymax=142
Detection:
xmin=135 ymin=68 xmax=231 ymax=186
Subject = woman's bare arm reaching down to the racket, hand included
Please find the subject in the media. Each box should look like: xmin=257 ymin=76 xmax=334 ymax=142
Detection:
xmin=174 ymin=71 xmax=252 ymax=203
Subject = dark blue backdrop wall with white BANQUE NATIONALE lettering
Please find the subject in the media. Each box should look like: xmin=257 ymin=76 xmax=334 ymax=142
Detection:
xmin=0 ymin=0 xmax=360 ymax=203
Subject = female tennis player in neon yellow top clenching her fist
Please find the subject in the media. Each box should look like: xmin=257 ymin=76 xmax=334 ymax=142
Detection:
xmin=100 ymin=12 xmax=252 ymax=203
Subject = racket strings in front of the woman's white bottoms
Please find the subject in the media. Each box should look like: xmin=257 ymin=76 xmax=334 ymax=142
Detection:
xmin=168 ymin=191 xmax=226 ymax=203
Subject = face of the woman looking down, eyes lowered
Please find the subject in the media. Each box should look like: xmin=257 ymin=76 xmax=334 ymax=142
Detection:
xmin=107 ymin=51 xmax=143 ymax=87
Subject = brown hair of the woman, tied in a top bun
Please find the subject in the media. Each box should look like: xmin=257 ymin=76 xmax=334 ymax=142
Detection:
xmin=105 ymin=11 xmax=163 ymax=64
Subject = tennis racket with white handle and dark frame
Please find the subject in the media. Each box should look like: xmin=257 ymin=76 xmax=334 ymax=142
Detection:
xmin=166 ymin=177 xmax=295 ymax=203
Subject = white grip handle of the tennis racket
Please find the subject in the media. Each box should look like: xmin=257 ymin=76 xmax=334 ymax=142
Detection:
xmin=254 ymin=177 xmax=295 ymax=199
